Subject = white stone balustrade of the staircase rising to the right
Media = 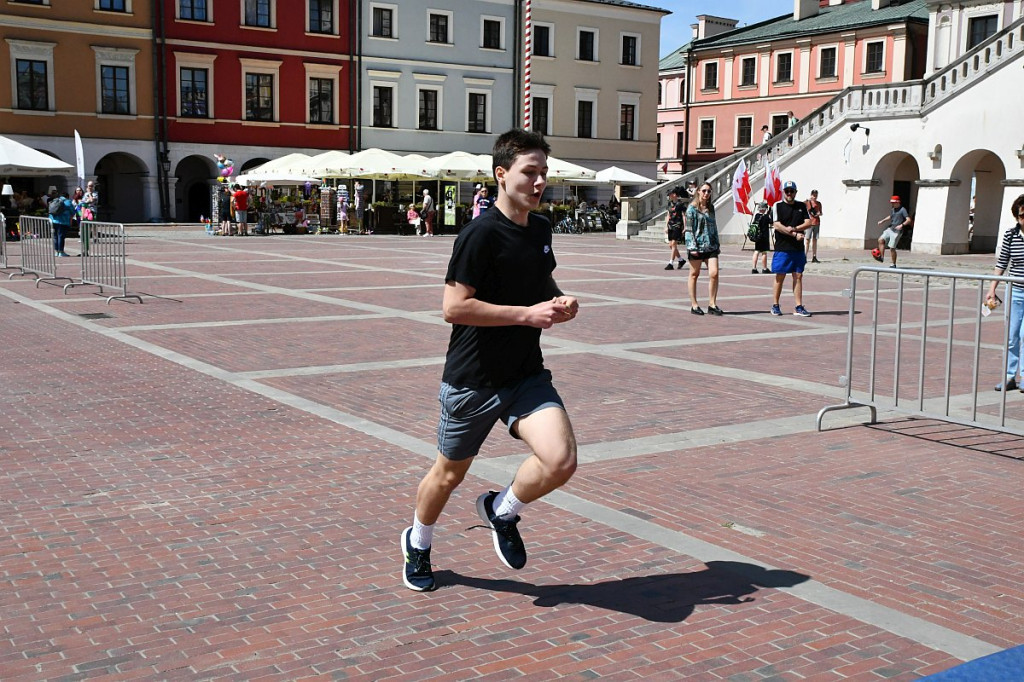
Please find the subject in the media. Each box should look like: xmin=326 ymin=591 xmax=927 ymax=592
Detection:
xmin=615 ymin=17 xmax=1024 ymax=238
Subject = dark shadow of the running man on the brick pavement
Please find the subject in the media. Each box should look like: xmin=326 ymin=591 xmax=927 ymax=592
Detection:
xmin=434 ymin=561 xmax=810 ymax=623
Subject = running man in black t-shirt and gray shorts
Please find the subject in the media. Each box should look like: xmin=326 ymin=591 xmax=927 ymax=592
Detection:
xmin=401 ymin=130 xmax=580 ymax=592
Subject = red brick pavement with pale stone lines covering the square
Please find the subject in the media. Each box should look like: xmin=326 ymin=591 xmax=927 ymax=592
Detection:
xmin=0 ymin=232 xmax=1024 ymax=682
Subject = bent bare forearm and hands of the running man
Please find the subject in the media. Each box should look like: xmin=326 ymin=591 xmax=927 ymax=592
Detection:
xmin=441 ymin=280 xmax=579 ymax=329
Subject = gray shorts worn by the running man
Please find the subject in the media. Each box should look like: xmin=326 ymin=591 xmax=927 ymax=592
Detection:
xmin=437 ymin=370 xmax=565 ymax=462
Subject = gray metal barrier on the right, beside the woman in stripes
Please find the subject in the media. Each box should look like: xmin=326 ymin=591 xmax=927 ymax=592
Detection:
xmin=817 ymin=267 xmax=1024 ymax=435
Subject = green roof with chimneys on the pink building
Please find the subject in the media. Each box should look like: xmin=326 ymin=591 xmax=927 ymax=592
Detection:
xmin=658 ymin=0 xmax=928 ymax=57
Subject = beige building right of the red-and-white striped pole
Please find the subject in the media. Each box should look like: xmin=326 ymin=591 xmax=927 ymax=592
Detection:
xmin=530 ymin=0 xmax=669 ymax=178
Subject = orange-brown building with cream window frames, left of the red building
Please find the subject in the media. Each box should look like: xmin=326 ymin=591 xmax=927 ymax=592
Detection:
xmin=0 ymin=0 xmax=157 ymax=221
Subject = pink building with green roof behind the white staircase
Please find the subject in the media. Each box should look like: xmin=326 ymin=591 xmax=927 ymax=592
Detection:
xmin=657 ymin=0 xmax=928 ymax=173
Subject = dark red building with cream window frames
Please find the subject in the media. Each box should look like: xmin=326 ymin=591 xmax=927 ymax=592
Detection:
xmin=154 ymin=0 xmax=357 ymax=221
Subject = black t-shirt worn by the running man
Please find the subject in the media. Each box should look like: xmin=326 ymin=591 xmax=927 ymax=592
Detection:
xmin=441 ymin=207 xmax=555 ymax=388
